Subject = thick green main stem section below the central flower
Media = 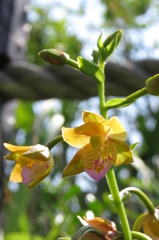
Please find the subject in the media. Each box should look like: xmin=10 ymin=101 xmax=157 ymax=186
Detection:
xmin=106 ymin=167 xmax=132 ymax=240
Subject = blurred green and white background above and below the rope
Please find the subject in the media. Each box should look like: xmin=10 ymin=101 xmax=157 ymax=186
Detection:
xmin=3 ymin=0 xmax=159 ymax=240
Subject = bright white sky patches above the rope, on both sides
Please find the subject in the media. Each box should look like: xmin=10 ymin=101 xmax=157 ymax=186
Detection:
xmin=30 ymin=0 xmax=159 ymax=58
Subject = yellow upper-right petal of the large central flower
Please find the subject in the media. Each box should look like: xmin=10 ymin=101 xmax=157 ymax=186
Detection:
xmin=103 ymin=117 xmax=127 ymax=141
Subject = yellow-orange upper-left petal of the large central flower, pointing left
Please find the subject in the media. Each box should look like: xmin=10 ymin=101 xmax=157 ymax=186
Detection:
xmin=62 ymin=122 xmax=104 ymax=148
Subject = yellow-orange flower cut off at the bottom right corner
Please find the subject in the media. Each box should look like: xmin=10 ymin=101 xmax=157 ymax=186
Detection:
xmin=134 ymin=206 xmax=159 ymax=240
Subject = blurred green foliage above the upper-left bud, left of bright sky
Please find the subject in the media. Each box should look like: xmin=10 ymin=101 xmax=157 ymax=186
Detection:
xmin=26 ymin=6 xmax=82 ymax=64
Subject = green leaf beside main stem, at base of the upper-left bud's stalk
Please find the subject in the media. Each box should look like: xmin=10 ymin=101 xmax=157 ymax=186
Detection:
xmin=77 ymin=56 xmax=104 ymax=82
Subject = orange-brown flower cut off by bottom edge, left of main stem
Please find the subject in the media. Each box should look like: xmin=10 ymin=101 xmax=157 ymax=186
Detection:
xmin=78 ymin=216 xmax=119 ymax=240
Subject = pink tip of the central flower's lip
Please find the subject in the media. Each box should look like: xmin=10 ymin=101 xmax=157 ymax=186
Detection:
xmin=84 ymin=166 xmax=111 ymax=181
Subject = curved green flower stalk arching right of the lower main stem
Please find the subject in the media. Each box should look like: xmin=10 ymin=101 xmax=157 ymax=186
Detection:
xmin=122 ymin=187 xmax=155 ymax=214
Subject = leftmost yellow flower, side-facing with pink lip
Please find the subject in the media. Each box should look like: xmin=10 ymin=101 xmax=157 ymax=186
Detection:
xmin=4 ymin=143 xmax=54 ymax=189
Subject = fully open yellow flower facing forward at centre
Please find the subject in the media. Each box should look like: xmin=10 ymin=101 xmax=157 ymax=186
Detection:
xmin=62 ymin=111 xmax=133 ymax=181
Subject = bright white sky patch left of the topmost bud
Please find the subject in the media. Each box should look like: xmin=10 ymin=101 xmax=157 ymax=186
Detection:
xmin=31 ymin=0 xmax=104 ymax=57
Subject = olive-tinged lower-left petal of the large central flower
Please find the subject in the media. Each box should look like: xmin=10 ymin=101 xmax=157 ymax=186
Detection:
xmin=62 ymin=148 xmax=84 ymax=178
